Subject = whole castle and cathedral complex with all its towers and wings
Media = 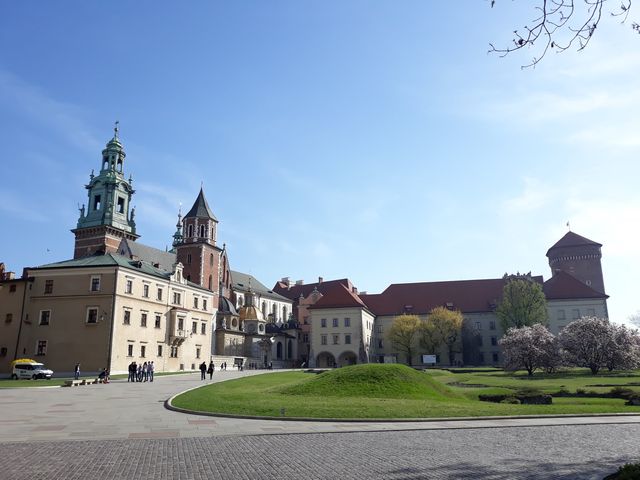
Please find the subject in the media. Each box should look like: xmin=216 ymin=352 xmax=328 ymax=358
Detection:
xmin=0 ymin=128 xmax=607 ymax=376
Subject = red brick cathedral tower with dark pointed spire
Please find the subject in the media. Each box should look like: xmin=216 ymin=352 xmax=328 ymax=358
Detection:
xmin=174 ymin=188 xmax=222 ymax=294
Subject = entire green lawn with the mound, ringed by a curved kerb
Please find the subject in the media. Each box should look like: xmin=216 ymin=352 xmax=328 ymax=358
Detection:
xmin=173 ymin=365 xmax=640 ymax=419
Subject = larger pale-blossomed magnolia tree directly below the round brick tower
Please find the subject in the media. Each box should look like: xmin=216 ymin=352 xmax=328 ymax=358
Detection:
xmin=558 ymin=317 xmax=616 ymax=375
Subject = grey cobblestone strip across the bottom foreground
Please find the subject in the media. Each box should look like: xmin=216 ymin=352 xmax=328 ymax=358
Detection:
xmin=0 ymin=425 xmax=640 ymax=480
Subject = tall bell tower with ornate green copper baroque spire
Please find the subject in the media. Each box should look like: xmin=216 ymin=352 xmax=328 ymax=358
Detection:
xmin=71 ymin=122 xmax=139 ymax=258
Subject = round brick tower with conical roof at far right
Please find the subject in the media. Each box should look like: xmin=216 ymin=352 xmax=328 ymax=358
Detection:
xmin=547 ymin=231 xmax=605 ymax=293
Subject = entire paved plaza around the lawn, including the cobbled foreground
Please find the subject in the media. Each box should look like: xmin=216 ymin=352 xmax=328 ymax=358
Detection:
xmin=0 ymin=371 xmax=640 ymax=480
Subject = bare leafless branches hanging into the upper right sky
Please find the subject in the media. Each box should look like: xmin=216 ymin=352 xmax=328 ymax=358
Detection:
xmin=489 ymin=0 xmax=640 ymax=68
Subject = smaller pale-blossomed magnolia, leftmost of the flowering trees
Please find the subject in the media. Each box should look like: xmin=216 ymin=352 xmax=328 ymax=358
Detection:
xmin=500 ymin=323 xmax=558 ymax=375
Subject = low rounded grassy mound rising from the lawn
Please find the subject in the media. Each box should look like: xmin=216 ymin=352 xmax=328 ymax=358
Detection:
xmin=279 ymin=364 xmax=458 ymax=400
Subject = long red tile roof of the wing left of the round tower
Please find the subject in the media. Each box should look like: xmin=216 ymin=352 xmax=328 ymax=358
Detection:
xmin=360 ymin=276 xmax=542 ymax=315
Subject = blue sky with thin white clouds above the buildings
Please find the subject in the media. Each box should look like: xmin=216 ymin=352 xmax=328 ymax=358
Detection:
xmin=0 ymin=0 xmax=640 ymax=322
